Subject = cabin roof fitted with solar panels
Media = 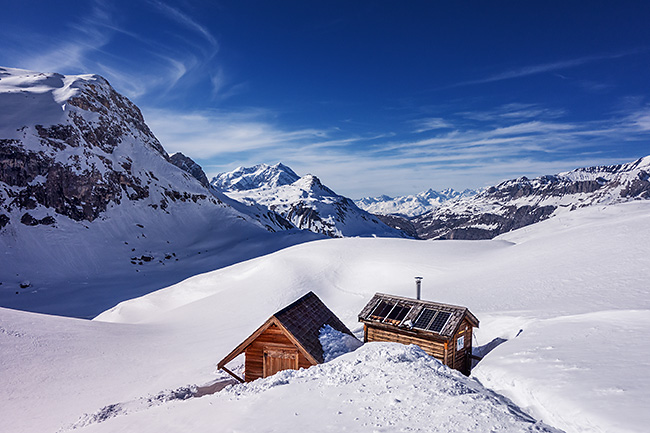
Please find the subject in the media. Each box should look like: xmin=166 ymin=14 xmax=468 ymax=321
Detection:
xmin=359 ymin=293 xmax=479 ymax=338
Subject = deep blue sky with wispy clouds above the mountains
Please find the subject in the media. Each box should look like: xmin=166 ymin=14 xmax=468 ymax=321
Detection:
xmin=0 ymin=0 xmax=650 ymax=198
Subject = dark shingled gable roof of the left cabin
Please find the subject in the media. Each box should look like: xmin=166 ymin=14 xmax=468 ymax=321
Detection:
xmin=273 ymin=292 xmax=354 ymax=362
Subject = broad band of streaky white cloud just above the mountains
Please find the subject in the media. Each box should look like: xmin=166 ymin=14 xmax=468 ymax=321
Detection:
xmin=144 ymin=104 xmax=650 ymax=198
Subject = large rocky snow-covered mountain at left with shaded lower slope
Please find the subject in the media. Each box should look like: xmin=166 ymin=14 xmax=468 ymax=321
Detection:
xmin=0 ymin=68 xmax=314 ymax=315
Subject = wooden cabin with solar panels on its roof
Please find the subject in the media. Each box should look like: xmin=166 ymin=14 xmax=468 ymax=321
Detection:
xmin=359 ymin=293 xmax=479 ymax=375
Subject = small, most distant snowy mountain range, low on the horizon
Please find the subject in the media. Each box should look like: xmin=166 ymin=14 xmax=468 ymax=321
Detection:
xmin=354 ymin=188 xmax=477 ymax=218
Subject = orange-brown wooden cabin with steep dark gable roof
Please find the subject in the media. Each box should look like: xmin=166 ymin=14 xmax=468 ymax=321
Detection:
xmin=217 ymin=292 xmax=352 ymax=382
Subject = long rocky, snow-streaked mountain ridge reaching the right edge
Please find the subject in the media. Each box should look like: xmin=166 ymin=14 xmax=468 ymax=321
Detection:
xmin=408 ymin=156 xmax=650 ymax=239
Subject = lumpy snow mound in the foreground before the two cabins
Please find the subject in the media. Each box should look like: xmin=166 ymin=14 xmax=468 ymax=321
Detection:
xmin=73 ymin=343 xmax=559 ymax=433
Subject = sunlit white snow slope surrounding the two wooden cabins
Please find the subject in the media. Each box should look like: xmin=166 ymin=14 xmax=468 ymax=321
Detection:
xmin=0 ymin=201 xmax=650 ymax=433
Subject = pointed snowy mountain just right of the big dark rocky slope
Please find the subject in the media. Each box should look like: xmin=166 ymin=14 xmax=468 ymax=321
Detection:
xmin=211 ymin=164 xmax=406 ymax=237
